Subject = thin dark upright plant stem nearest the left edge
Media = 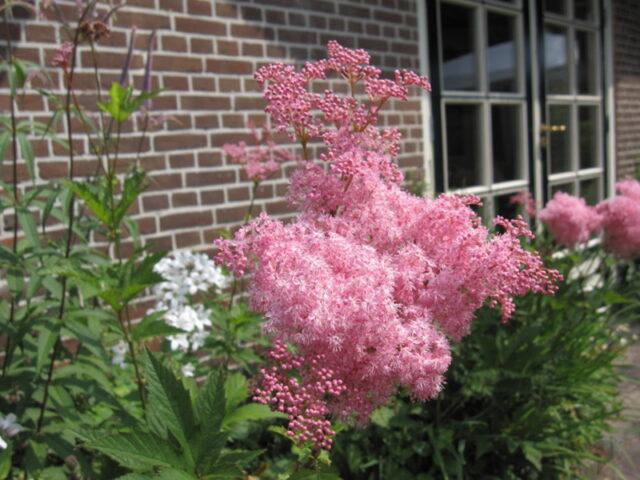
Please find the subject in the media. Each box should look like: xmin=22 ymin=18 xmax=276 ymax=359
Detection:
xmin=2 ymin=6 xmax=19 ymax=377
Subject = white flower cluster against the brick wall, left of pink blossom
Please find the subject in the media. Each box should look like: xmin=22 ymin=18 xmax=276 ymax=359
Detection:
xmin=150 ymin=251 xmax=229 ymax=352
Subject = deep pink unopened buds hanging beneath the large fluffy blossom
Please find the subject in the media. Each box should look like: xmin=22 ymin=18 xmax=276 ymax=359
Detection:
xmin=253 ymin=342 xmax=345 ymax=450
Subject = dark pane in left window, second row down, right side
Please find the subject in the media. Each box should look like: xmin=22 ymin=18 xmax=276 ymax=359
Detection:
xmin=491 ymin=105 xmax=522 ymax=182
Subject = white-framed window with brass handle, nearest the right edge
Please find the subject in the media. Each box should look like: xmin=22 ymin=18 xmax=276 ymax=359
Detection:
xmin=542 ymin=0 xmax=604 ymax=203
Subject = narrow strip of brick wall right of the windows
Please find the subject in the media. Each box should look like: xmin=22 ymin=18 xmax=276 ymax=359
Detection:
xmin=613 ymin=0 xmax=640 ymax=178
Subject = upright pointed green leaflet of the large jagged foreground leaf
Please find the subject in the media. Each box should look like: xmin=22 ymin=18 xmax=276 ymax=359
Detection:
xmin=145 ymin=350 xmax=196 ymax=463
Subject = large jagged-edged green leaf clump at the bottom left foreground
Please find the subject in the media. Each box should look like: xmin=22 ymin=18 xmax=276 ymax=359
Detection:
xmin=85 ymin=352 xmax=274 ymax=479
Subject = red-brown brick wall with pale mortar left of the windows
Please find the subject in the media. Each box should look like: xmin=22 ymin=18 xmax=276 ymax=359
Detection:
xmin=0 ymin=0 xmax=430 ymax=253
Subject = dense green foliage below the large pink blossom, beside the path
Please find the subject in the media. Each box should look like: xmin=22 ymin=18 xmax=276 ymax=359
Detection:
xmin=332 ymin=255 xmax=637 ymax=479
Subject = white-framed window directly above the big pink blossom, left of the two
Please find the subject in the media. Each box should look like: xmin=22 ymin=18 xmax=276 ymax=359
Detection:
xmin=436 ymin=0 xmax=529 ymax=216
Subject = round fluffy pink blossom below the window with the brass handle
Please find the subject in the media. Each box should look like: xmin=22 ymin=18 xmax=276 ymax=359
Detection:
xmin=538 ymin=192 xmax=601 ymax=247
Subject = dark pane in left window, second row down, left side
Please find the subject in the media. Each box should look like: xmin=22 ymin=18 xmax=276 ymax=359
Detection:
xmin=445 ymin=104 xmax=482 ymax=189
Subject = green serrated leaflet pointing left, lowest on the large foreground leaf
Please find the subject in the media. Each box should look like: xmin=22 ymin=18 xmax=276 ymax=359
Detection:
xmin=87 ymin=431 xmax=186 ymax=470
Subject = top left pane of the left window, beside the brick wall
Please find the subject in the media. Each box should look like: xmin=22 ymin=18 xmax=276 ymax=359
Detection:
xmin=440 ymin=3 xmax=478 ymax=90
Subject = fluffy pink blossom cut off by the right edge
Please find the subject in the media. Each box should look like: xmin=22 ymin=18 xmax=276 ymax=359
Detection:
xmin=597 ymin=179 xmax=640 ymax=260
